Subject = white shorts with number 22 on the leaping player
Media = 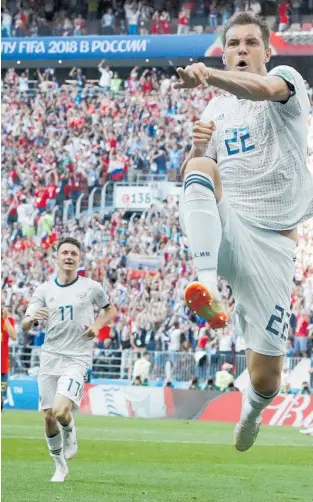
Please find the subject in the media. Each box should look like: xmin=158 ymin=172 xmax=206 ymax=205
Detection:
xmin=181 ymin=189 xmax=296 ymax=356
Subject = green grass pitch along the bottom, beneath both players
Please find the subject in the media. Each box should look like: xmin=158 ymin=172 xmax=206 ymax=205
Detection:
xmin=2 ymin=411 xmax=313 ymax=502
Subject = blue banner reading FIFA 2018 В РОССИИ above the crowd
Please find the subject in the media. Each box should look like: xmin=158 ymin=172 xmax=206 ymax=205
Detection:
xmin=1 ymin=34 xmax=221 ymax=61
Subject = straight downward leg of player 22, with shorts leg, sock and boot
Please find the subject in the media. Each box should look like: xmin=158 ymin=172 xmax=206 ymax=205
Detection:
xmin=234 ymin=225 xmax=296 ymax=451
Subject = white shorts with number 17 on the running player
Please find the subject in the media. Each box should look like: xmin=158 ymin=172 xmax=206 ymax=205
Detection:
xmin=38 ymin=359 xmax=88 ymax=410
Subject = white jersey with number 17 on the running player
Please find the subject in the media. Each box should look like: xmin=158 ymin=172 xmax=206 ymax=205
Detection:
xmin=26 ymin=276 xmax=110 ymax=362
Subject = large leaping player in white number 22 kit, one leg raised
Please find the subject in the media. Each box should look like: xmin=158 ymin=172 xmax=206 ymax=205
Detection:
xmin=176 ymin=12 xmax=313 ymax=451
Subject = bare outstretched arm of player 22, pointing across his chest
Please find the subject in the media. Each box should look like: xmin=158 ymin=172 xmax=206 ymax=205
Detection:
xmin=174 ymin=63 xmax=290 ymax=101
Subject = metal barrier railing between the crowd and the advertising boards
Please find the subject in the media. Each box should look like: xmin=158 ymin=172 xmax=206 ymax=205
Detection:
xmin=10 ymin=345 xmax=302 ymax=382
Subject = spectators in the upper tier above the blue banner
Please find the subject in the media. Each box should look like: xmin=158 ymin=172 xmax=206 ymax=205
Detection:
xmin=2 ymin=0 xmax=313 ymax=37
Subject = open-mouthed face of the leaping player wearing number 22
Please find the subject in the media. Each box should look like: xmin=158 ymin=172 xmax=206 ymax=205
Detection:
xmin=223 ymin=24 xmax=271 ymax=75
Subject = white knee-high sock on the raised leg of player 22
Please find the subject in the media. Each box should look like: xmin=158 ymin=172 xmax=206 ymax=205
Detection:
xmin=184 ymin=171 xmax=222 ymax=299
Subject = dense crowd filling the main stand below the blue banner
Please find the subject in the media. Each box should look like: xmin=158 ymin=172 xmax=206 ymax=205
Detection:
xmin=2 ymin=63 xmax=313 ymax=379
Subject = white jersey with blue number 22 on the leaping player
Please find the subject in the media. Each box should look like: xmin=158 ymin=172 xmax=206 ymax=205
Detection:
xmin=201 ymin=66 xmax=313 ymax=231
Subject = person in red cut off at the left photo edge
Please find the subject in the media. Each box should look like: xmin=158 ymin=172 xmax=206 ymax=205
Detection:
xmin=1 ymin=304 xmax=17 ymax=411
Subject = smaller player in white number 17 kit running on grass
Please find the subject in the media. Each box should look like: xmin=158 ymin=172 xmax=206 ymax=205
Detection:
xmin=22 ymin=237 xmax=116 ymax=482
